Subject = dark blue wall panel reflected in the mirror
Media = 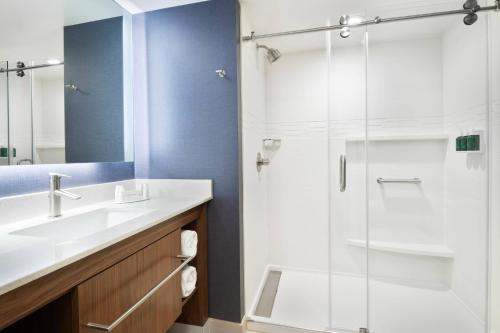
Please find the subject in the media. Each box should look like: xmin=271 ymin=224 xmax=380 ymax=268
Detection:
xmin=64 ymin=17 xmax=124 ymax=163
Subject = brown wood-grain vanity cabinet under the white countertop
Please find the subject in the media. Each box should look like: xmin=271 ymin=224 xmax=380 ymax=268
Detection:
xmin=0 ymin=204 xmax=208 ymax=333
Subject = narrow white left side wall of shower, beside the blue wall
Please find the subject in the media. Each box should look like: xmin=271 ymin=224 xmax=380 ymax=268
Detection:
xmin=241 ymin=4 xmax=270 ymax=311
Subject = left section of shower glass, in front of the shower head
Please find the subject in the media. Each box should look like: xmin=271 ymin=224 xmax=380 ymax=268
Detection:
xmin=243 ymin=30 xmax=329 ymax=331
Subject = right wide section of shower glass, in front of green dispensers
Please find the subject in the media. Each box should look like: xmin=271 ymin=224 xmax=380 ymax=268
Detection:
xmin=367 ymin=3 xmax=488 ymax=333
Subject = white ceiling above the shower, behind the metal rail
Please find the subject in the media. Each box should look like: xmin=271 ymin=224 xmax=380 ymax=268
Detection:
xmin=241 ymin=0 xmax=463 ymax=53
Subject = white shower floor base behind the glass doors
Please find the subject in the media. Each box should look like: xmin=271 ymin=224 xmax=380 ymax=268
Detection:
xmin=248 ymin=267 xmax=485 ymax=333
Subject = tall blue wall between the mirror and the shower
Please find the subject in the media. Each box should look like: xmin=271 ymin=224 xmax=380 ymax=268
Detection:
xmin=134 ymin=0 xmax=243 ymax=322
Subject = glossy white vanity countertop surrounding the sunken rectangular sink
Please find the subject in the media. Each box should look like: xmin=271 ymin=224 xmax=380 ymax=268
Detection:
xmin=0 ymin=180 xmax=212 ymax=295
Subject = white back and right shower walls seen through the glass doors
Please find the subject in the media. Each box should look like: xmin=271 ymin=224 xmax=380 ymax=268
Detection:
xmin=244 ymin=13 xmax=494 ymax=333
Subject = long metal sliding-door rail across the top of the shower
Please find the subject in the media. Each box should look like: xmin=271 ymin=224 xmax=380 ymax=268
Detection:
xmin=242 ymin=0 xmax=500 ymax=42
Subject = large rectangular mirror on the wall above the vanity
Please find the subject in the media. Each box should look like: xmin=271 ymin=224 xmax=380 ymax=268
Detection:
xmin=0 ymin=0 xmax=134 ymax=165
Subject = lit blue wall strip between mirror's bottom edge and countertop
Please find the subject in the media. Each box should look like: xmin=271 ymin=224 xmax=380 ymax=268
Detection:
xmin=0 ymin=162 xmax=134 ymax=197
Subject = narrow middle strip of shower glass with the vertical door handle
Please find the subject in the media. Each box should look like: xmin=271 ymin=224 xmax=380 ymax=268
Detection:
xmin=328 ymin=25 xmax=368 ymax=332
